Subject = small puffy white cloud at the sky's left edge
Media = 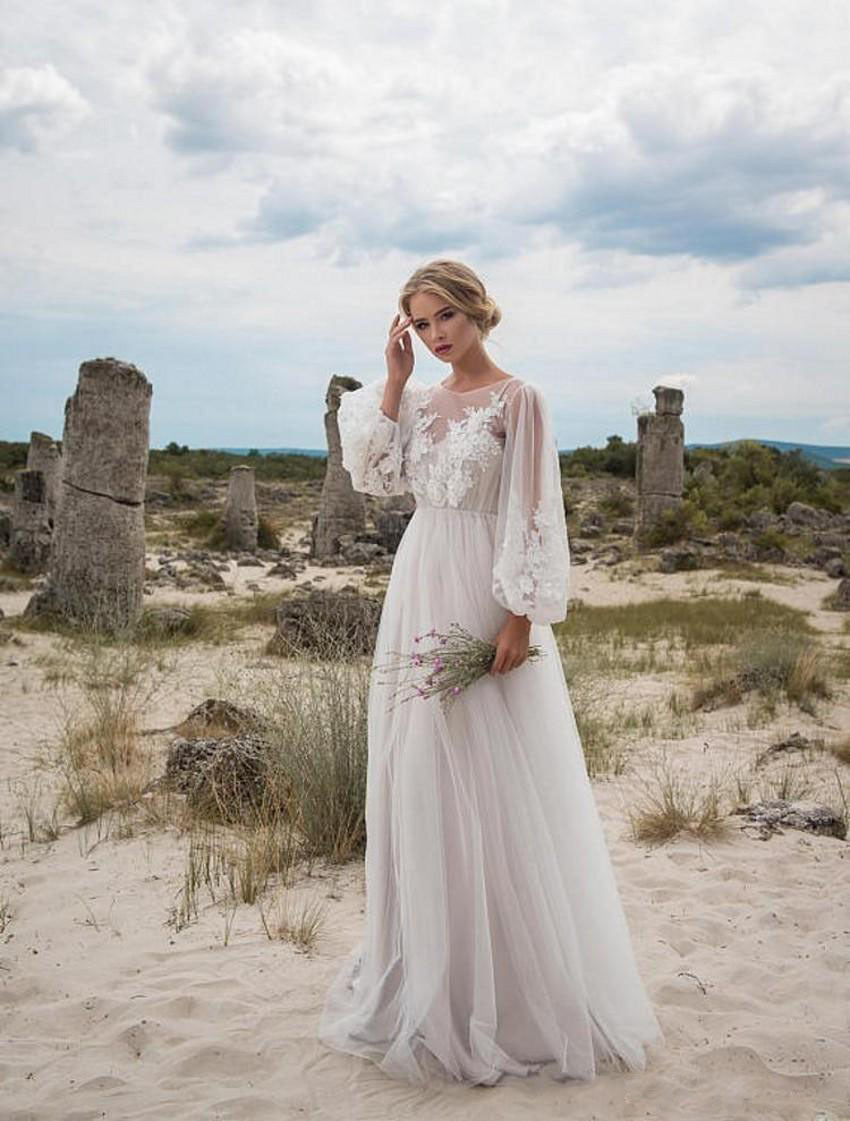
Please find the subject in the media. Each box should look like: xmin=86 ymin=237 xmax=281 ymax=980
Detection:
xmin=0 ymin=63 xmax=89 ymax=152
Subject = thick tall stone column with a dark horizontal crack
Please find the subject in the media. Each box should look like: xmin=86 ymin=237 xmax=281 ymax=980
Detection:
xmin=26 ymin=358 xmax=153 ymax=631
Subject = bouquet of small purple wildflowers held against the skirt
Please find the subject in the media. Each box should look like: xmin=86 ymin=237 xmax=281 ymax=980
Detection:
xmin=373 ymin=623 xmax=544 ymax=710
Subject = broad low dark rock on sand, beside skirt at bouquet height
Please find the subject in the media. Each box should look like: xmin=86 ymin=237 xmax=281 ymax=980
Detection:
xmin=267 ymin=587 xmax=381 ymax=656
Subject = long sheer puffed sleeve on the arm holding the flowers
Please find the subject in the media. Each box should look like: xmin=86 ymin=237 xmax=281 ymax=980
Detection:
xmin=492 ymin=381 xmax=570 ymax=623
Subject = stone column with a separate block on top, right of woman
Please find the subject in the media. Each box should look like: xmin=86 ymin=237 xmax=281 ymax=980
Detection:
xmin=635 ymin=386 xmax=685 ymax=537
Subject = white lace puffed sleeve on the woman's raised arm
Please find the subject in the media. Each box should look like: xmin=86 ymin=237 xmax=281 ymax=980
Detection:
xmin=336 ymin=379 xmax=415 ymax=497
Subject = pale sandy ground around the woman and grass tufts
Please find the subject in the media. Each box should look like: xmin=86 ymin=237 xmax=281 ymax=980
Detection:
xmin=0 ymin=553 xmax=850 ymax=1121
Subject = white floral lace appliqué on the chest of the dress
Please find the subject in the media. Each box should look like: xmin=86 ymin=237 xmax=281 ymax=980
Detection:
xmin=407 ymin=391 xmax=502 ymax=507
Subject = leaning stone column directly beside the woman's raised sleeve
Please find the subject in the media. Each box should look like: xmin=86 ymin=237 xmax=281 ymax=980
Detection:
xmin=311 ymin=374 xmax=366 ymax=557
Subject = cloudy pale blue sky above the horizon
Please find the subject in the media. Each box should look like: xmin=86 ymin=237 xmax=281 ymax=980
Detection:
xmin=0 ymin=0 xmax=850 ymax=450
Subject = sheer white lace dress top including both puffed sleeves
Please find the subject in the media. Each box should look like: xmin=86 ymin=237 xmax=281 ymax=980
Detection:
xmin=339 ymin=378 xmax=570 ymax=622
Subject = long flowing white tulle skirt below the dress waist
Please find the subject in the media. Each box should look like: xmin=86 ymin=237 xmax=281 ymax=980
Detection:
xmin=318 ymin=504 xmax=663 ymax=1085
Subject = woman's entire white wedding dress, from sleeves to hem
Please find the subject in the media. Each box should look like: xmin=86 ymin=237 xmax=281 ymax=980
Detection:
xmin=318 ymin=378 xmax=663 ymax=1085
